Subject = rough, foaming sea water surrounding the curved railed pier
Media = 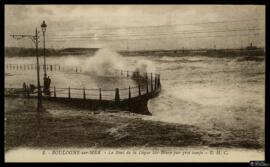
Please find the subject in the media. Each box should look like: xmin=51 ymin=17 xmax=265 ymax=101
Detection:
xmin=5 ymin=50 xmax=265 ymax=149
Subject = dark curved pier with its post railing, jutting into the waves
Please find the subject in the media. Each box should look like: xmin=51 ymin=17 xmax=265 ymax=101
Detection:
xmin=5 ymin=64 xmax=161 ymax=115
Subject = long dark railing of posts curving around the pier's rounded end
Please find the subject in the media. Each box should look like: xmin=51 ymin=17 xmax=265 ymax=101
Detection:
xmin=5 ymin=64 xmax=161 ymax=101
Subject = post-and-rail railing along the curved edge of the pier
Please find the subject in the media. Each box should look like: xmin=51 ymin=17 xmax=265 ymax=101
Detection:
xmin=5 ymin=64 xmax=160 ymax=99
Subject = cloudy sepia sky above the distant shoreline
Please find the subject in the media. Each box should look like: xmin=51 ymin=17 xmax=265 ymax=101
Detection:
xmin=5 ymin=5 xmax=265 ymax=50
